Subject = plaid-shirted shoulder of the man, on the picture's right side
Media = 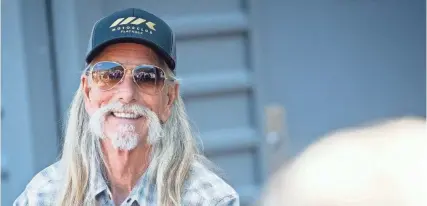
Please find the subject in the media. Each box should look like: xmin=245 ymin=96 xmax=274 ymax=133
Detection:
xmin=183 ymin=163 xmax=239 ymax=206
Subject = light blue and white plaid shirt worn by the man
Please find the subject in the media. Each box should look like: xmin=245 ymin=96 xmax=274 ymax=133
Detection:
xmin=13 ymin=162 xmax=240 ymax=206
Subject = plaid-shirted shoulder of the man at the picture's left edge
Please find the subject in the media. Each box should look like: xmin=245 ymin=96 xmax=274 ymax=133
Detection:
xmin=13 ymin=162 xmax=61 ymax=206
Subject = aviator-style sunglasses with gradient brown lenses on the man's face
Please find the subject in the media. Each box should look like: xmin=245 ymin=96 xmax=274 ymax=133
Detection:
xmin=86 ymin=61 xmax=174 ymax=95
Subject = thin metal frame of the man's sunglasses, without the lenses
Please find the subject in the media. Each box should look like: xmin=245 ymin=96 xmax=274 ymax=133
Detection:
xmin=85 ymin=61 xmax=176 ymax=95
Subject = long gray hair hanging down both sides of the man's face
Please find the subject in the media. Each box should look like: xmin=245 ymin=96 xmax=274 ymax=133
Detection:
xmin=58 ymin=70 xmax=209 ymax=206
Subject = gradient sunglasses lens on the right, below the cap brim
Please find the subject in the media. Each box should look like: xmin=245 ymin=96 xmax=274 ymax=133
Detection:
xmin=133 ymin=65 xmax=165 ymax=94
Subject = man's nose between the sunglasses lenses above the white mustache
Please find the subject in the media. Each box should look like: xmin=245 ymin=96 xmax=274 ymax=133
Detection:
xmin=115 ymin=75 xmax=137 ymax=104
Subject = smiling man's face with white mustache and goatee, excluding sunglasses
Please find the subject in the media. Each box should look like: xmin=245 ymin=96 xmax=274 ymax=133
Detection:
xmin=82 ymin=43 xmax=178 ymax=150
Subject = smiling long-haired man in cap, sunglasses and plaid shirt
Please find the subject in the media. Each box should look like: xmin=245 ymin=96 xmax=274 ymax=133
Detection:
xmin=14 ymin=8 xmax=239 ymax=206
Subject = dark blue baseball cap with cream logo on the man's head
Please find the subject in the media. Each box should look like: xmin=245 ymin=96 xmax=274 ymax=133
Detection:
xmin=86 ymin=8 xmax=176 ymax=72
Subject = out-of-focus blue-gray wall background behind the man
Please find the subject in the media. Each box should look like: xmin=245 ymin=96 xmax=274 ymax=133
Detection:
xmin=1 ymin=0 xmax=426 ymax=205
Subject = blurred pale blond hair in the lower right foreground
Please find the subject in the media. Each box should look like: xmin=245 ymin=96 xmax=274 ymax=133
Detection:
xmin=261 ymin=117 xmax=427 ymax=206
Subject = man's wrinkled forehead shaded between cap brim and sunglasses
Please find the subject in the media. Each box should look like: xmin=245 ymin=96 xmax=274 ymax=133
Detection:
xmin=93 ymin=43 xmax=160 ymax=66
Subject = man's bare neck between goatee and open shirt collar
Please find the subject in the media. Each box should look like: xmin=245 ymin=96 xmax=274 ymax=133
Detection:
xmin=101 ymin=138 xmax=150 ymax=203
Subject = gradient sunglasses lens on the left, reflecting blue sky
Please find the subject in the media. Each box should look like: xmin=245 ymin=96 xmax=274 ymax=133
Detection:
xmin=91 ymin=62 xmax=125 ymax=90
